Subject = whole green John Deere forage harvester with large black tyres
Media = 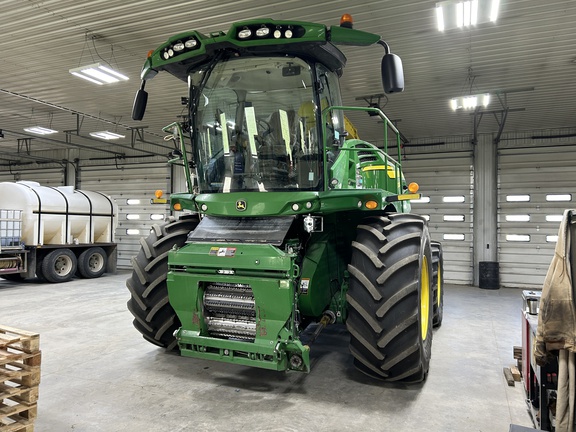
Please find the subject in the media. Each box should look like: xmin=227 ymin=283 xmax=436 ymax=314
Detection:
xmin=127 ymin=15 xmax=442 ymax=382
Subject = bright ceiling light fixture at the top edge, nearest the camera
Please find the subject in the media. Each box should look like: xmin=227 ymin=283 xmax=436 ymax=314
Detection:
xmin=436 ymin=0 xmax=500 ymax=31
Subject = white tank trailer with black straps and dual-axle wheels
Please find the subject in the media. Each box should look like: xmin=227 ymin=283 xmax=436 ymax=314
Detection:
xmin=0 ymin=181 xmax=118 ymax=283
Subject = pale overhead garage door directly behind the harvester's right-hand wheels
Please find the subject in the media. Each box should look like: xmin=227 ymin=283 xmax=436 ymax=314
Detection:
xmin=402 ymin=151 xmax=473 ymax=284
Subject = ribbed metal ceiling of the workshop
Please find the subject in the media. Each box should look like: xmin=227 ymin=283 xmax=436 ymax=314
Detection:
xmin=0 ymin=0 xmax=576 ymax=166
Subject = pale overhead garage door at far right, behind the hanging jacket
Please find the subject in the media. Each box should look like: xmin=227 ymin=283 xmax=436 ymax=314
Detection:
xmin=498 ymin=146 xmax=576 ymax=288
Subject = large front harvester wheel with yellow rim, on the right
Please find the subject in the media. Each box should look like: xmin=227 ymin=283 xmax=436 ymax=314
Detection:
xmin=346 ymin=214 xmax=432 ymax=382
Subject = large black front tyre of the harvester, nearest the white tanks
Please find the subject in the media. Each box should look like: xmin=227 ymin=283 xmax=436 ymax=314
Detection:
xmin=126 ymin=215 xmax=199 ymax=350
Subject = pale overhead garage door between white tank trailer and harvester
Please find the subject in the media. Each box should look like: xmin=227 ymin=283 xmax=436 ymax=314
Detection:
xmin=79 ymin=162 xmax=170 ymax=269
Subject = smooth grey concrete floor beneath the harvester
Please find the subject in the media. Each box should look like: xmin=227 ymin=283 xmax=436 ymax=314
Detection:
xmin=0 ymin=273 xmax=532 ymax=432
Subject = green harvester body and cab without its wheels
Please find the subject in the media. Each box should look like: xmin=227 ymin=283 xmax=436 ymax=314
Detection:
xmin=135 ymin=19 xmax=426 ymax=371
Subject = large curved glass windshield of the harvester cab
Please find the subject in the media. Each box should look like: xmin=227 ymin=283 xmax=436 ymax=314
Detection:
xmin=189 ymin=57 xmax=323 ymax=193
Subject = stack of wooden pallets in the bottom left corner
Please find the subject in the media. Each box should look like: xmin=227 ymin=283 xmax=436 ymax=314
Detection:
xmin=0 ymin=325 xmax=42 ymax=432
